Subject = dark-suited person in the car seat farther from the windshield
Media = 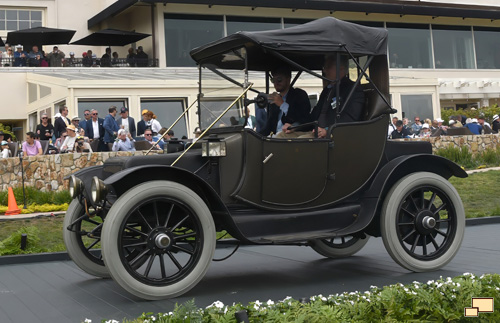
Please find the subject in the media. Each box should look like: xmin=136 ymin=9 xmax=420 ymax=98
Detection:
xmin=302 ymin=54 xmax=365 ymax=138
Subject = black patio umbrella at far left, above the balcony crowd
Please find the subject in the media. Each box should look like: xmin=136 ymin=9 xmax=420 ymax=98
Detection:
xmin=7 ymin=27 xmax=76 ymax=45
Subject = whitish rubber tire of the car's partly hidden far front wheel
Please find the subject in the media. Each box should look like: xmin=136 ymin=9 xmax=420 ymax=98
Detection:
xmin=63 ymin=199 xmax=109 ymax=278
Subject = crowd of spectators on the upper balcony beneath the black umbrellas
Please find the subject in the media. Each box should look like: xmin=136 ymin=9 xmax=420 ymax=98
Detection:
xmin=0 ymin=44 xmax=151 ymax=67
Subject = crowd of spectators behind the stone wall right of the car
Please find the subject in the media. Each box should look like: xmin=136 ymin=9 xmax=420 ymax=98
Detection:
xmin=387 ymin=115 xmax=500 ymax=139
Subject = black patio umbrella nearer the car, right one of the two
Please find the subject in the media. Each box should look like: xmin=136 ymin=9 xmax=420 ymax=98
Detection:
xmin=71 ymin=29 xmax=151 ymax=46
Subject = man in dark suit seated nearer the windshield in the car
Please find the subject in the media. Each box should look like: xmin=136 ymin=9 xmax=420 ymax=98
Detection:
xmin=260 ymin=66 xmax=311 ymax=138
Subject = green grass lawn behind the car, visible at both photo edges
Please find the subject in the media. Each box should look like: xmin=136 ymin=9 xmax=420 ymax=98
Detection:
xmin=0 ymin=171 xmax=500 ymax=252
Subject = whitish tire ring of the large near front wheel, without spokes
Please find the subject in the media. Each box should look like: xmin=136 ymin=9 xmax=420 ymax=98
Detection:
xmin=102 ymin=181 xmax=216 ymax=300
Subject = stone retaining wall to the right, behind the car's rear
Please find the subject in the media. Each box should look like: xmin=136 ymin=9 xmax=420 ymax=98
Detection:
xmin=397 ymin=134 xmax=500 ymax=154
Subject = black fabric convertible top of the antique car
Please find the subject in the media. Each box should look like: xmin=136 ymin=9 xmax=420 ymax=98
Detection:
xmin=190 ymin=17 xmax=387 ymax=71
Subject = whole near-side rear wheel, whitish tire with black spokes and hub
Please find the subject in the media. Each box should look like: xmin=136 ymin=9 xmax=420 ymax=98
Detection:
xmin=381 ymin=172 xmax=465 ymax=272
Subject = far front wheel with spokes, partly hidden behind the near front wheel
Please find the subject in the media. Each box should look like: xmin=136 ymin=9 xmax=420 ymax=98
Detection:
xmin=63 ymin=199 xmax=109 ymax=278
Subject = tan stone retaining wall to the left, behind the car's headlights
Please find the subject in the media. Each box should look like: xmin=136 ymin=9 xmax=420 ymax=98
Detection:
xmin=0 ymin=151 xmax=161 ymax=191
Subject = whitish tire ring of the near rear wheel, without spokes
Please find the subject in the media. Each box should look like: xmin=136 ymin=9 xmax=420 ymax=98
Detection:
xmin=380 ymin=172 xmax=465 ymax=272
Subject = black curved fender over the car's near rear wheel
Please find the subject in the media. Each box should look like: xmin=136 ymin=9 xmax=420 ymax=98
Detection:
xmin=361 ymin=154 xmax=467 ymax=237
